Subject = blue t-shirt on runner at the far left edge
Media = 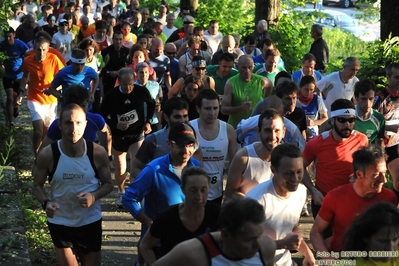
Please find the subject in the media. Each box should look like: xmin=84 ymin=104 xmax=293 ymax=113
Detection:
xmin=0 ymin=39 xmax=29 ymax=79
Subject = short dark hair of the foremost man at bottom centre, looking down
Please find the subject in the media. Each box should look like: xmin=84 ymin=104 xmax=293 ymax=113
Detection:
xmin=218 ymin=197 xmax=266 ymax=235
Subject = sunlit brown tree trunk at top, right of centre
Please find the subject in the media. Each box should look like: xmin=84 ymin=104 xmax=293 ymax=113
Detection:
xmin=255 ymin=0 xmax=280 ymax=24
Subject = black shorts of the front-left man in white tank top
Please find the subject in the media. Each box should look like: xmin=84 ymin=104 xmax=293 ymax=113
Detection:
xmin=47 ymin=219 xmax=102 ymax=254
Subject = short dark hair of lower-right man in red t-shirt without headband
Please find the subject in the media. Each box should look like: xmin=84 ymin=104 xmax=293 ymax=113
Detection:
xmin=352 ymin=144 xmax=387 ymax=178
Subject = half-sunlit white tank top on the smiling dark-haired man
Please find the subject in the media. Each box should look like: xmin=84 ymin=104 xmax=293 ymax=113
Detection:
xmin=240 ymin=142 xmax=273 ymax=194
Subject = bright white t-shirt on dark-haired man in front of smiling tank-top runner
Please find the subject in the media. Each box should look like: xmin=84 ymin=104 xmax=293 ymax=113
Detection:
xmin=245 ymin=179 xmax=306 ymax=266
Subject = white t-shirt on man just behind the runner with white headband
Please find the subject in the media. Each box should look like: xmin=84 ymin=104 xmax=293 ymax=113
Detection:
xmin=316 ymin=72 xmax=359 ymax=116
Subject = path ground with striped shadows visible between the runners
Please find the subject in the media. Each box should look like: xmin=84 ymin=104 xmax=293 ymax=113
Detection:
xmin=0 ymin=90 xmax=313 ymax=266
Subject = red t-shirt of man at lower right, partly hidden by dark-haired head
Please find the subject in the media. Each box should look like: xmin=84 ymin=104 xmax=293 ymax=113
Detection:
xmin=318 ymin=184 xmax=398 ymax=252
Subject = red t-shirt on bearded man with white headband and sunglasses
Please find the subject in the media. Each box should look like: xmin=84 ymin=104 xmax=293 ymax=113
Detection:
xmin=303 ymin=130 xmax=368 ymax=195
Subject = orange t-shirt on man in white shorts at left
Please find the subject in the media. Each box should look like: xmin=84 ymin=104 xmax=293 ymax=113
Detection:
xmin=22 ymin=53 xmax=64 ymax=104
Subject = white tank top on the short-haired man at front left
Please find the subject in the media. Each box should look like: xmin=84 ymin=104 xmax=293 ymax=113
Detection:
xmin=47 ymin=141 xmax=101 ymax=227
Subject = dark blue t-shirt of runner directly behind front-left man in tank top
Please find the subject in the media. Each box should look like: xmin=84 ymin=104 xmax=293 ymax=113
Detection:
xmin=47 ymin=112 xmax=105 ymax=142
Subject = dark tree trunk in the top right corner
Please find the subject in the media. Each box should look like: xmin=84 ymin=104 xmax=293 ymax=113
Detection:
xmin=381 ymin=0 xmax=399 ymax=41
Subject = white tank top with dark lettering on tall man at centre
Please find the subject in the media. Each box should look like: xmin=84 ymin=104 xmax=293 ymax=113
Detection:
xmin=190 ymin=119 xmax=229 ymax=200
